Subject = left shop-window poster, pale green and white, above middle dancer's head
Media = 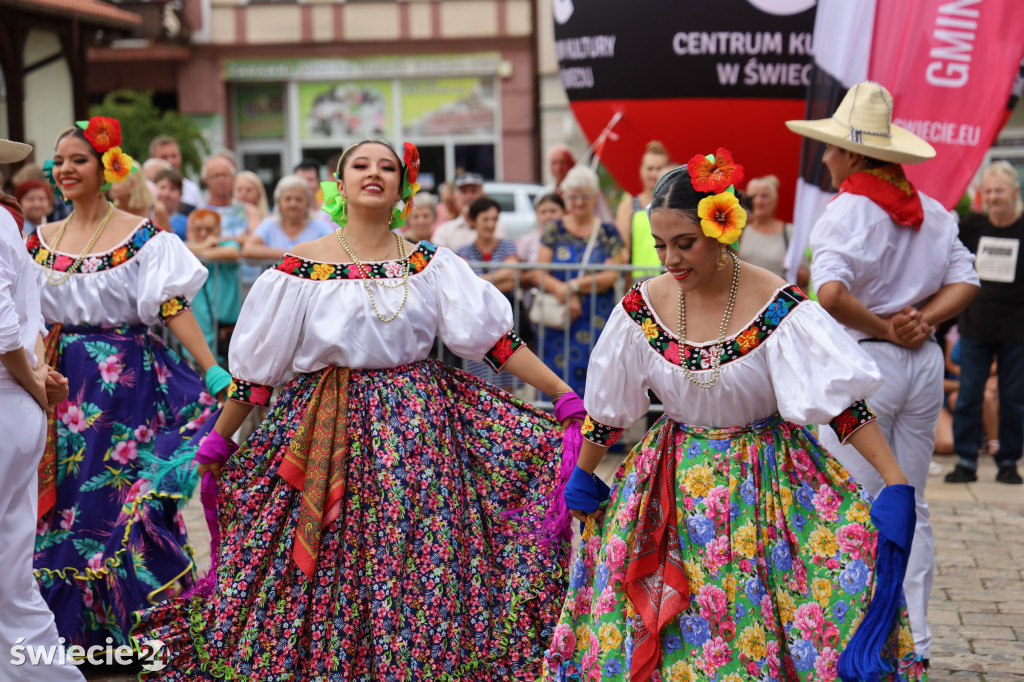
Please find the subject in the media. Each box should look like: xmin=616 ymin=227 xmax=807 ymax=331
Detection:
xmin=299 ymin=81 xmax=391 ymax=141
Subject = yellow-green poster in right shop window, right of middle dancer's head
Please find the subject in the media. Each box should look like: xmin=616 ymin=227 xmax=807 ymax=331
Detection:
xmin=401 ymin=78 xmax=497 ymax=139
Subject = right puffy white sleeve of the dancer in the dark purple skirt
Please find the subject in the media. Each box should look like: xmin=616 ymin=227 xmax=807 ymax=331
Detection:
xmin=135 ymin=231 xmax=208 ymax=325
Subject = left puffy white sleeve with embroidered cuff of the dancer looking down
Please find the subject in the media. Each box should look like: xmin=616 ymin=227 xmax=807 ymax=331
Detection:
xmin=583 ymin=303 xmax=651 ymax=445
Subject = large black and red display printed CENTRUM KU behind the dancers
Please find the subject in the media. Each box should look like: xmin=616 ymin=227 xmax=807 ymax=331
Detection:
xmin=553 ymin=0 xmax=815 ymax=212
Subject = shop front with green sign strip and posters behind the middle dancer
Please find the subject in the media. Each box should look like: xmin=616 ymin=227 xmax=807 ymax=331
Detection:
xmin=226 ymin=53 xmax=501 ymax=186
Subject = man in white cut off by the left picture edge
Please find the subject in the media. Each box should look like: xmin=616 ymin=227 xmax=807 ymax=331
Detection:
xmin=0 ymin=139 xmax=85 ymax=682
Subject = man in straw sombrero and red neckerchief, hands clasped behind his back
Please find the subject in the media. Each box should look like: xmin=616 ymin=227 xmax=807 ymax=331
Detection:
xmin=786 ymin=81 xmax=979 ymax=660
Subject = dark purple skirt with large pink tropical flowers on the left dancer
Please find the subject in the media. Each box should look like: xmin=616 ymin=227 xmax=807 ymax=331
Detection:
xmin=35 ymin=326 xmax=216 ymax=647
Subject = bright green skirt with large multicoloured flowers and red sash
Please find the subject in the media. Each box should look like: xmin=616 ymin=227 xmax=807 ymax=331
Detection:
xmin=548 ymin=415 xmax=924 ymax=682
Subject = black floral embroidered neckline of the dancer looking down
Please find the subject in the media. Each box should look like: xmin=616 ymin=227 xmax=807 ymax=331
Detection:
xmin=622 ymin=282 xmax=807 ymax=372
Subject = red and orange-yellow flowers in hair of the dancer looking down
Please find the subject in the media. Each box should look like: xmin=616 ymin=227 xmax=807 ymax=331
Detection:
xmin=686 ymin=147 xmax=746 ymax=244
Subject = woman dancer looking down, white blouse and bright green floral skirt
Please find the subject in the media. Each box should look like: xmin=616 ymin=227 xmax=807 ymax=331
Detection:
xmin=548 ymin=150 xmax=921 ymax=680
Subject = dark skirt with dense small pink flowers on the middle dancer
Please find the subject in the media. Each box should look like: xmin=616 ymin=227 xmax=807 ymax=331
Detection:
xmin=133 ymin=360 xmax=570 ymax=682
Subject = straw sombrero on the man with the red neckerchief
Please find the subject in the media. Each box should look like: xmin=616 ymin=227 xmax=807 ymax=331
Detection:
xmin=785 ymin=81 xmax=935 ymax=164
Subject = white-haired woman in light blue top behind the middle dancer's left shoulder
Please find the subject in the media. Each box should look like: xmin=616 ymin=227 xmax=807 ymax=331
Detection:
xmin=242 ymin=175 xmax=334 ymax=258
